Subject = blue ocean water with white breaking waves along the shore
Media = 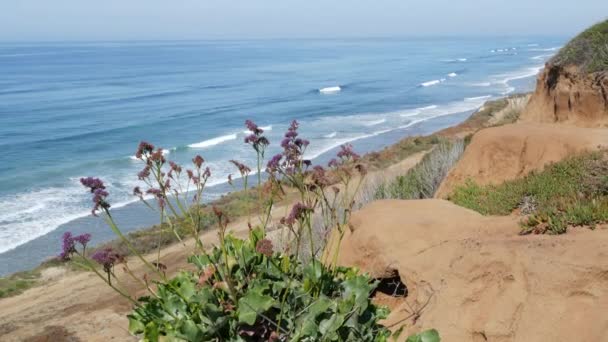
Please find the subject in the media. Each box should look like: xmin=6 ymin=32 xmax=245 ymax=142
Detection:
xmin=0 ymin=37 xmax=565 ymax=274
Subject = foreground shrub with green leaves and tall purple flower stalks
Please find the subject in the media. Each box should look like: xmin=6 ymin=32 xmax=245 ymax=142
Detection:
xmin=61 ymin=121 xmax=436 ymax=341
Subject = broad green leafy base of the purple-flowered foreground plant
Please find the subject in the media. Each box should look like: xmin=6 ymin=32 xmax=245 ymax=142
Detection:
xmin=129 ymin=229 xmax=390 ymax=341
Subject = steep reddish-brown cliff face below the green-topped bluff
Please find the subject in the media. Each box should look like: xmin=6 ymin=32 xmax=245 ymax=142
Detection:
xmin=520 ymin=64 xmax=608 ymax=127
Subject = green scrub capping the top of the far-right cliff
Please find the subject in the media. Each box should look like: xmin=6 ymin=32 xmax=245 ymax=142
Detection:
xmin=550 ymin=20 xmax=608 ymax=73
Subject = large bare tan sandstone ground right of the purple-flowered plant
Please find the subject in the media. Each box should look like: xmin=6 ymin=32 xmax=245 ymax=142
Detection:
xmin=340 ymin=200 xmax=608 ymax=342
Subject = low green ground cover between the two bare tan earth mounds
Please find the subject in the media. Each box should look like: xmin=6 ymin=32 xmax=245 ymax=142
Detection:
xmin=449 ymin=150 xmax=608 ymax=234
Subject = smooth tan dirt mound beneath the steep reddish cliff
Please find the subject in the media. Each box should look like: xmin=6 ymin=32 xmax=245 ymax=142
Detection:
xmin=435 ymin=123 xmax=608 ymax=198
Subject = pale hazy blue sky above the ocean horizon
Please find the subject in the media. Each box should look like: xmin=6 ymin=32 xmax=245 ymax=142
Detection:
xmin=0 ymin=0 xmax=608 ymax=41
